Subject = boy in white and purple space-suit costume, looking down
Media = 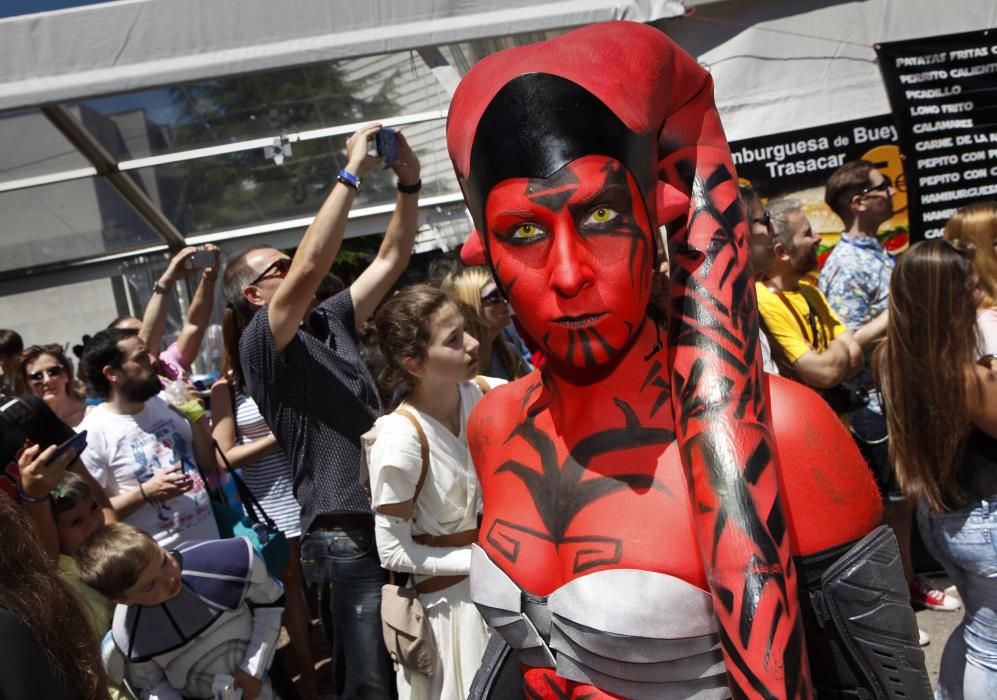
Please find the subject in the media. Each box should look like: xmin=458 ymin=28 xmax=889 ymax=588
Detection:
xmin=76 ymin=523 xmax=284 ymax=700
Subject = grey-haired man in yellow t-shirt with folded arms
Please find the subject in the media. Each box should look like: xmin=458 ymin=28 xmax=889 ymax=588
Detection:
xmin=755 ymin=199 xmax=862 ymax=400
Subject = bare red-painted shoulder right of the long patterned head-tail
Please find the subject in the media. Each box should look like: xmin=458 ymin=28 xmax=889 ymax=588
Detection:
xmin=769 ymin=376 xmax=882 ymax=554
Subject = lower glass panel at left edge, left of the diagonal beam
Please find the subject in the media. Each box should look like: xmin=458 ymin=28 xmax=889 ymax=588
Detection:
xmin=0 ymin=177 xmax=162 ymax=270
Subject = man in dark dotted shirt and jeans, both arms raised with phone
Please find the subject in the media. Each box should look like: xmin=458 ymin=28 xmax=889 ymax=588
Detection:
xmin=223 ymin=124 xmax=421 ymax=699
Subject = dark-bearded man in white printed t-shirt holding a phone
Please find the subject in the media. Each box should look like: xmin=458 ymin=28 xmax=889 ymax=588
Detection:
xmin=78 ymin=328 xmax=218 ymax=548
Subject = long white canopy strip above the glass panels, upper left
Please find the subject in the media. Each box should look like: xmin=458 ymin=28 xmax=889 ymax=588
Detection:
xmin=0 ymin=0 xmax=696 ymax=110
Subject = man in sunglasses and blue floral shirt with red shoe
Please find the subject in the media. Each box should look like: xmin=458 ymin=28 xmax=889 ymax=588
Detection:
xmin=819 ymin=160 xmax=960 ymax=624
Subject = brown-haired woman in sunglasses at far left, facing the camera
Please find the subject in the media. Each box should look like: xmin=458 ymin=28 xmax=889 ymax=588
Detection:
xmin=19 ymin=344 xmax=92 ymax=428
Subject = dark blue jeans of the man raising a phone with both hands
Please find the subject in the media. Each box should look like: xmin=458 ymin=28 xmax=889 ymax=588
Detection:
xmin=301 ymin=527 xmax=394 ymax=700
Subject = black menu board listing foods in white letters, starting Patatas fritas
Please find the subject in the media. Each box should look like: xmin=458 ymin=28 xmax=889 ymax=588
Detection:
xmin=876 ymin=29 xmax=997 ymax=240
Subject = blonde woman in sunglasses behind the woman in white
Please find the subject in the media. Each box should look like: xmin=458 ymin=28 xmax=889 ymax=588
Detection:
xmin=442 ymin=266 xmax=532 ymax=381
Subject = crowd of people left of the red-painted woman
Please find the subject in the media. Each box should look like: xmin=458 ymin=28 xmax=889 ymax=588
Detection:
xmin=0 ymin=125 xmax=532 ymax=699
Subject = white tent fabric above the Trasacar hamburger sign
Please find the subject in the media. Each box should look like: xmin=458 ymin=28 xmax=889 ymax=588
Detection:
xmin=659 ymin=0 xmax=997 ymax=140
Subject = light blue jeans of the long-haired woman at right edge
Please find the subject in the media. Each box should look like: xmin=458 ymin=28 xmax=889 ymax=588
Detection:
xmin=917 ymin=496 xmax=997 ymax=700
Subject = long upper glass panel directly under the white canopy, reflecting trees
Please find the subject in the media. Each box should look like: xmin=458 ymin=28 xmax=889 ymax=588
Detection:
xmin=80 ymin=51 xmax=450 ymax=160
